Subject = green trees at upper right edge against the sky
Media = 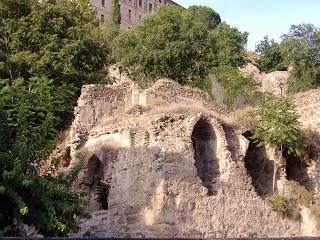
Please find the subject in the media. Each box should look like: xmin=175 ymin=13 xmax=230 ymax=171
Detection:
xmin=256 ymin=24 xmax=320 ymax=93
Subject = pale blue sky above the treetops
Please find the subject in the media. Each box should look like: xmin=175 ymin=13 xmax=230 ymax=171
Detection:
xmin=175 ymin=0 xmax=320 ymax=50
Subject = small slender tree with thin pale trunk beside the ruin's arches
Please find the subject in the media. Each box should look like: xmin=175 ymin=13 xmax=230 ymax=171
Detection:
xmin=252 ymin=98 xmax=308 ymax=191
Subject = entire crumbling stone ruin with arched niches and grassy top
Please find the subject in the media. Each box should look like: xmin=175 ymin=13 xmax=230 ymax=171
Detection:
xmin=58 ymin=72 xmax=318 ymax=238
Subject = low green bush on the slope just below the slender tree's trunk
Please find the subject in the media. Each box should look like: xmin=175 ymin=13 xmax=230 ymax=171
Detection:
xmin=265 ymin=193 xmax=293 ymax=217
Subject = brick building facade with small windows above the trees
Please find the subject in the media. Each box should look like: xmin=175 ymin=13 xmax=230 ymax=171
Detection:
xmin=92 ymin=0 xmax=178 ymax=27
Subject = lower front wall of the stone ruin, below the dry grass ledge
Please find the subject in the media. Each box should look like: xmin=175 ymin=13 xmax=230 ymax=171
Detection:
xmin=69 ymin=113 xmax=299 ymax=238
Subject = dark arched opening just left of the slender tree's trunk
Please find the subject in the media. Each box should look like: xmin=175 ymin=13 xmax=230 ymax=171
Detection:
xmin=243 ymin=132 xmax=273 ymax=196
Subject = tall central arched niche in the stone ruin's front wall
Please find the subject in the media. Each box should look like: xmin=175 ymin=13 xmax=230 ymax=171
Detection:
xmin=192 ymin=119 xmax=219 ymax=196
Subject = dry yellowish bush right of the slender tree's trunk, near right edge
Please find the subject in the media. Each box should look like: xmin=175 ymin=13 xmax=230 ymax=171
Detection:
xmin=289 ymin=181 xmax=313 ymax=207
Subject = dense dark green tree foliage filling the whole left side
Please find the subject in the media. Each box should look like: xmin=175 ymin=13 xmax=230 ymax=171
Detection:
xmin=0 ymin=0 xmax=110 ymax=236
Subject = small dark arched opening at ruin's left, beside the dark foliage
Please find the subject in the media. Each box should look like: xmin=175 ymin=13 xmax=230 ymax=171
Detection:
xmin=85 ymin=155 xmax=110 ymax=211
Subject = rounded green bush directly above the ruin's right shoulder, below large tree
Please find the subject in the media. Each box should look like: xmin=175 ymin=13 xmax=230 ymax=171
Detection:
xmin=208 ymin=66 xmax=262 ymax=108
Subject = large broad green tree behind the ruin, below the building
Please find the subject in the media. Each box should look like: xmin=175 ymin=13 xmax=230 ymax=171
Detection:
xmin=113 ymin=6 xmax=245 ymax=86
